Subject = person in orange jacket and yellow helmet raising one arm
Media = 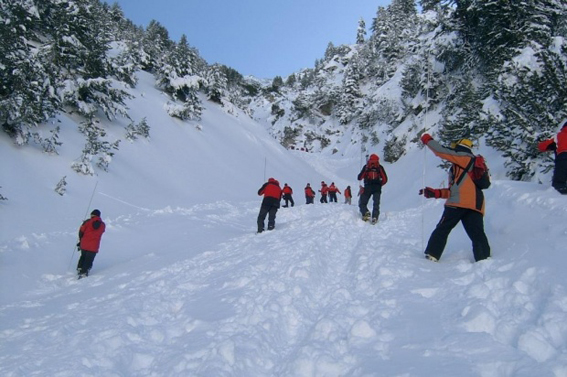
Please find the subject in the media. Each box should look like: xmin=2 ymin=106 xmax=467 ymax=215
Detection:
xmin=419 ymin=133 xmax=490 ymax=262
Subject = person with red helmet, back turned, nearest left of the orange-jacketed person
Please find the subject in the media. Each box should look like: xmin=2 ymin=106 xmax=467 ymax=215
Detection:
xmin=358 ymin=154 xmax=388 ymax=224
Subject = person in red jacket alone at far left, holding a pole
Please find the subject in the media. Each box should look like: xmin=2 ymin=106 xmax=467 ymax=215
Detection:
xmin=77 ymin=209 xmax=106 ymax=279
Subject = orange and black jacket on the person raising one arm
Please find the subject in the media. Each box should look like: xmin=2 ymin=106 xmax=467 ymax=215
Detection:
xmin=427 ymin=140 xmax=484 ymax=215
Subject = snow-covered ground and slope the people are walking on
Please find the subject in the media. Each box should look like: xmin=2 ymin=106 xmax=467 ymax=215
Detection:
xmin=0 ymin=74 xmax=567 ymax=377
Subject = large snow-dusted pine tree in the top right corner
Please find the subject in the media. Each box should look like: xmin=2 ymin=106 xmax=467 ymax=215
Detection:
xmin=487 ymin=1 xmax=567 ymax=180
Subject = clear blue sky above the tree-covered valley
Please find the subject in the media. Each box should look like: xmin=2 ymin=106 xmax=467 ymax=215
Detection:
xmin=107 ymin=0 xmax=391 ymax=78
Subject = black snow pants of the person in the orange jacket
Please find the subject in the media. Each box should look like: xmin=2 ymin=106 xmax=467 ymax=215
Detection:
xmin=425 ymin=207 xmax=490 ymax=262
